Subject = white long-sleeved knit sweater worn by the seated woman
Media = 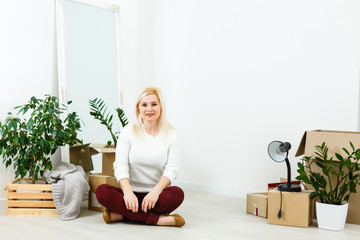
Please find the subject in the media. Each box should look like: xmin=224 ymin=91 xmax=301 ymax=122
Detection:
xmin=114 ymin=124 xmax=181 ymax=192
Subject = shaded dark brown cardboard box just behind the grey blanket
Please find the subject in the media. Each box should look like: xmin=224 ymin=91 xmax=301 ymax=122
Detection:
xmin=70 ymin=143 xmax=99 ymax=172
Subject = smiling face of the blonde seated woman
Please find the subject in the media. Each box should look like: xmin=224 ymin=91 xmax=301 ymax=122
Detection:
xmin=139 ymin=94 xmax=161 ymax=122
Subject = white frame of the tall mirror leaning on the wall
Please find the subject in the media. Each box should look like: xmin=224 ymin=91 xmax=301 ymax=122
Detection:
xmin=56 ymin=0 xmax=123 ymax=162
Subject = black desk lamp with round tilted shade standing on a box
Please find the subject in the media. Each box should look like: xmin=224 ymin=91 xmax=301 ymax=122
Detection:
xmin=268 ymin=141 xmax=301 ymax=192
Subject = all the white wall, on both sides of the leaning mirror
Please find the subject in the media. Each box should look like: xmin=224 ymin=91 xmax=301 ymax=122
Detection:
xmin=0 ymin=0 xmax=360 ymax=198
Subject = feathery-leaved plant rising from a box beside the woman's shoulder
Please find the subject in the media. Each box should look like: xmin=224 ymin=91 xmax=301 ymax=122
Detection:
xmin=89 ymin=98 xmax=129 ymax=147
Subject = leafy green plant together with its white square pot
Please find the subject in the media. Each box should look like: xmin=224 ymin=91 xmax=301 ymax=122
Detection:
xmin=296 ymin=142 xmax=360 ymax=231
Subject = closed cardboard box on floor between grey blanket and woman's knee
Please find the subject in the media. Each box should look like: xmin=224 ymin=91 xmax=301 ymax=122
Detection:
xmin=88 ymin=174 xmax=120 ymax=212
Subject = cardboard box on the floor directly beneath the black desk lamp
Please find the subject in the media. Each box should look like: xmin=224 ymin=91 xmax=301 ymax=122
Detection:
xmin=268 ymin=189 xmax=313 ymax=227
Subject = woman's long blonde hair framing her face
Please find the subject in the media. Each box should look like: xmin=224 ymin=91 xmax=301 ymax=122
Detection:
xmin=134 ymin=87 xmax=173 ymax=138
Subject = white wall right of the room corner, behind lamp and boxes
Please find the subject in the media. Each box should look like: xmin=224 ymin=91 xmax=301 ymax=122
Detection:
xmin=150 ymin=0 xmax=360 ymax=196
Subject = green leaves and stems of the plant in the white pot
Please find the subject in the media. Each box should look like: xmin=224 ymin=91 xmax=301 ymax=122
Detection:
xmin=296 ymin=142 xmax=360 ymax=205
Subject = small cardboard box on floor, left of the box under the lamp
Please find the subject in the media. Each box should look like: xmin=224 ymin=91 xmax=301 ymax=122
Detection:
xmin=246 ymin=192 xmax=268 ymax=218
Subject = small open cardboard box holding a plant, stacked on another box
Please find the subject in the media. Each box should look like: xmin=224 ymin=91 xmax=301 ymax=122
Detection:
xmin=90 ymin=143 xmax=116 ymax=176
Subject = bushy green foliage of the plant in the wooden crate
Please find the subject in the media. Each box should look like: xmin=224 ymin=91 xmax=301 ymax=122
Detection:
xmin=0 ymin=95 xmax=82 ymax=183
